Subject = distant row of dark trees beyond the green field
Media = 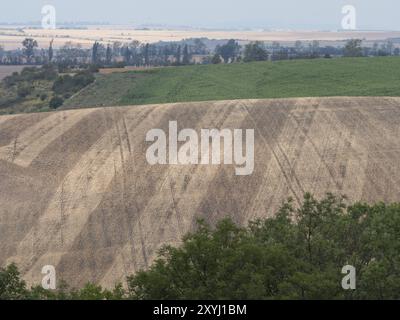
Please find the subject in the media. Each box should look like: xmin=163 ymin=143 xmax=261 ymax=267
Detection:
xmin=0 ymin=38 xmax=400 ymax=67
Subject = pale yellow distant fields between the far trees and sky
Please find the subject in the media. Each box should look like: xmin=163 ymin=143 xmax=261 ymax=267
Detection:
xmin=0 ymin=26 xmax=400 ymax=49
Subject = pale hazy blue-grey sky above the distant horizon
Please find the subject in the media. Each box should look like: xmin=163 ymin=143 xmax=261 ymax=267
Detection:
xmin=0 ymin=0 xmax=400 ymax=30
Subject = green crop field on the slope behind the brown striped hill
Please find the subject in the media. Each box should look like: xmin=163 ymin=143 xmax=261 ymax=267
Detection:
xmin=64 ymin=57 xmax=400 ymax=108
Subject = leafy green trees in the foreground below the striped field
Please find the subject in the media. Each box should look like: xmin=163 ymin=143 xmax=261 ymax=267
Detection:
xmin=0 ymin=194 xmax=400 ymax=300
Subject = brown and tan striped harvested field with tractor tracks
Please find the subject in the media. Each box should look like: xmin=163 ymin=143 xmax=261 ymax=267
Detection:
xmin=0 ymin=98 xmax=400 ymax=286
